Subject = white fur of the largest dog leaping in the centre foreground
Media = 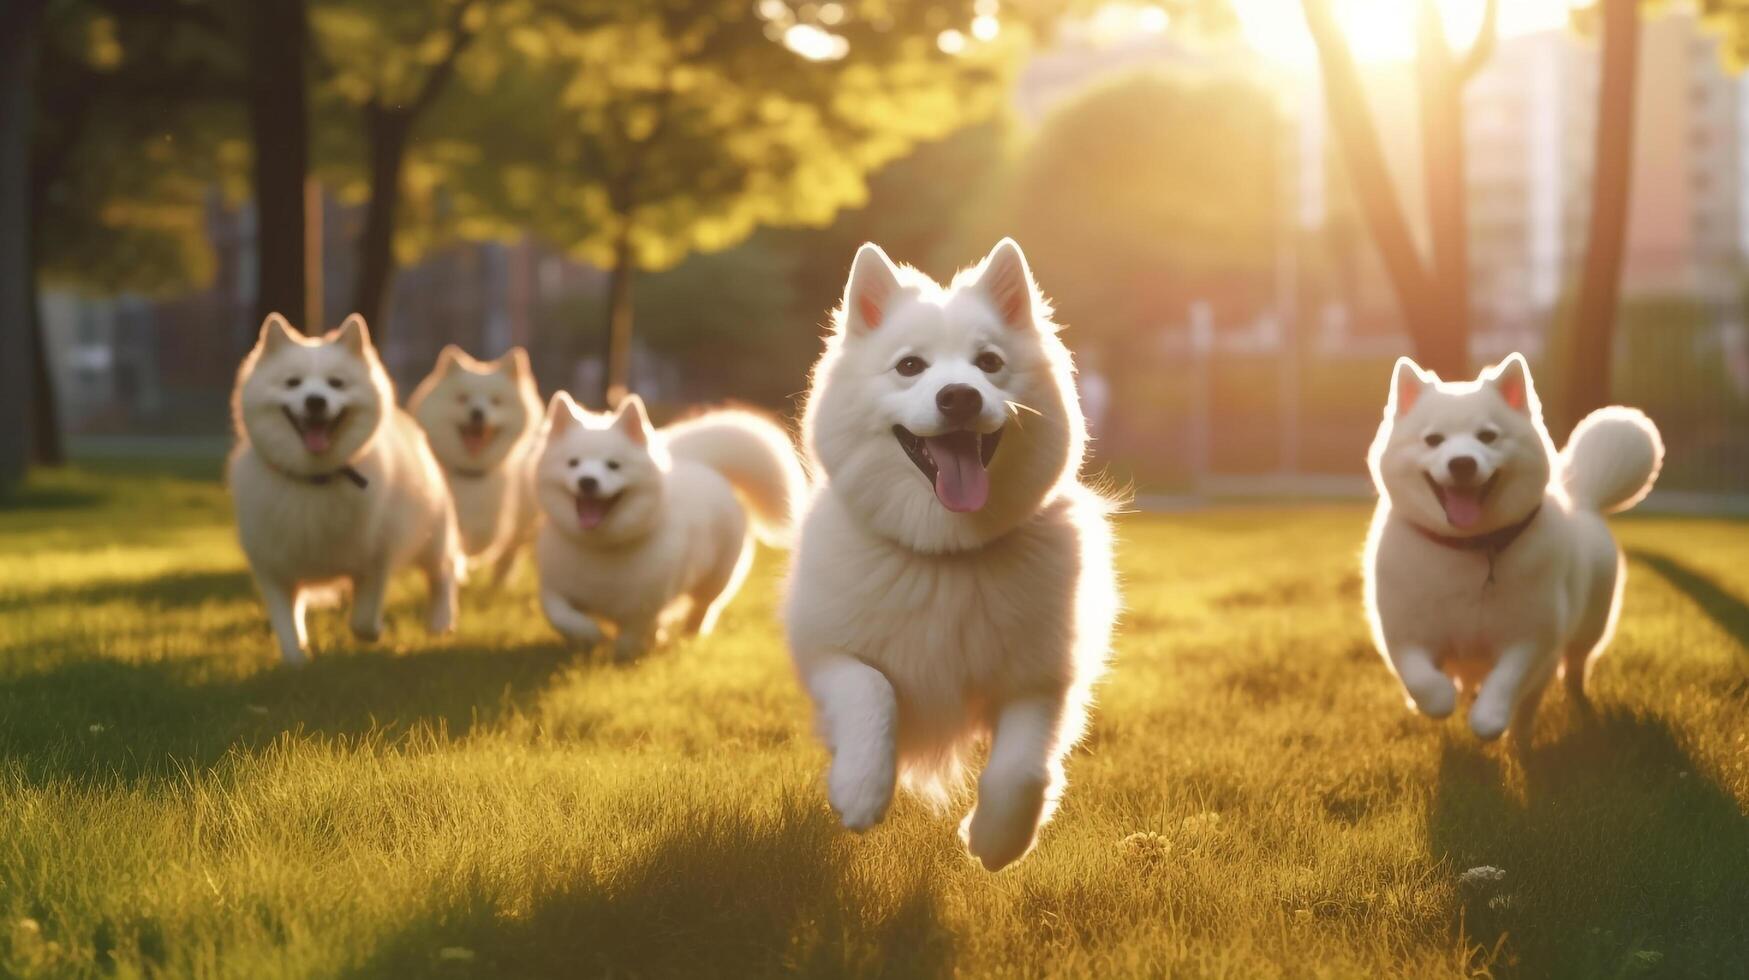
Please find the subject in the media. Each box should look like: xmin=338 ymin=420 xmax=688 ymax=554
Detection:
xmin=785 ymin=240 xmax=1118 ymax=870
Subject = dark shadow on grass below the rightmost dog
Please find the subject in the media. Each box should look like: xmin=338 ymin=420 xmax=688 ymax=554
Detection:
xmin=1427 ymin=711 xmax=1749 ymax=977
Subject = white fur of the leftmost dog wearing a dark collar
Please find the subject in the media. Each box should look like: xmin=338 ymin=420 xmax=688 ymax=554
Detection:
xmin=229 ymin=313 xmax=460 ymax=663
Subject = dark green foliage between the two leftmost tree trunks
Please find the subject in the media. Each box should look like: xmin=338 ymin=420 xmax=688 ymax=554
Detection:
xmin=31 ymin=0 xmax=248 ymax=292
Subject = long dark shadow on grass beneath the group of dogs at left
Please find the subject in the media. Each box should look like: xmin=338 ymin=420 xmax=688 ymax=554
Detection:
xmin=0 ymin=644 xmax=581 ymax=782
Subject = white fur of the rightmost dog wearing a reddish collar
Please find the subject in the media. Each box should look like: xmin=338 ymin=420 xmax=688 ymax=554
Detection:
xmin=1366 ymin=354 xmax=1663 ymax=742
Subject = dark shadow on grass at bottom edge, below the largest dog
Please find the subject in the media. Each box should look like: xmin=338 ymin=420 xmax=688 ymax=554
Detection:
xmin=342 ymin=798 xmax=953 ymax=978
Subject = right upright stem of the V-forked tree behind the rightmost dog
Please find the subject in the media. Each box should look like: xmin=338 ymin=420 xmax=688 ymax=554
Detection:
xmin=1415 ymin=0 xmax=1471 ymax=380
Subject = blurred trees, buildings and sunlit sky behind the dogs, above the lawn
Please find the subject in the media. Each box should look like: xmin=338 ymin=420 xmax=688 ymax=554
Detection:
xmin=0 ymin=0 xmax=1749 ymax=508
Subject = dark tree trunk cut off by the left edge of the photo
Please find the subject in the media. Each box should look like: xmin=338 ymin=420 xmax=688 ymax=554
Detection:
xmin=0 ymin=9 xmax=42 ymax=490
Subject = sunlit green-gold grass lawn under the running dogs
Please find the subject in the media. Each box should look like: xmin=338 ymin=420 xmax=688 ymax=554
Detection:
xmin=0 ymin=471 xmax=1749 ymax=978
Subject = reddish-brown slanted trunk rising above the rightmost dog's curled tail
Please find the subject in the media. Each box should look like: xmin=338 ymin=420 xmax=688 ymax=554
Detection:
xmin=1560 ymin=0 xmax=1641 ymax=427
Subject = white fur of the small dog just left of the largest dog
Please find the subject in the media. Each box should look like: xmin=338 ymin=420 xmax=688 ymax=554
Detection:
xmin=535 ymin=392 xmax=806 ymax=660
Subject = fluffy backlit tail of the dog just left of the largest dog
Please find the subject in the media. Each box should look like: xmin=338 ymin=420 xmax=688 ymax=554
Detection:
xmin=665 ymin=408 xmax=808 ymax=548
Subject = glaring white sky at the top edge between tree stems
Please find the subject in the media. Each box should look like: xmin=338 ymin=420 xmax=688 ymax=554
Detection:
xmin=1231 ymin=0 xmax=1569 ymax=65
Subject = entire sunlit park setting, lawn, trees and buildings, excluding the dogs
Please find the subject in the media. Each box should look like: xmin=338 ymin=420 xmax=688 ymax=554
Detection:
xmin=0 ymin=0 xmax=1749 ymax=980
